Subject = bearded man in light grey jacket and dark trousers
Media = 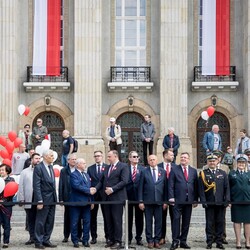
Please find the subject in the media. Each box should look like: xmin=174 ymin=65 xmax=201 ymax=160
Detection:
xmin=18 ymin=153 xmax=40 ymax=245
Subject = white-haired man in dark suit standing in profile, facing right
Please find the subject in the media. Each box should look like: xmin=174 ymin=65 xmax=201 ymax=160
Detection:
xmin=33 ymin=149 xmax=56 ymax=249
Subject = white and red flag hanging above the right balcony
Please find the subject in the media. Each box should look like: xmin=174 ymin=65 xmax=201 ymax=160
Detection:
xmin=202 ymin=0 xmax=230 ymax=75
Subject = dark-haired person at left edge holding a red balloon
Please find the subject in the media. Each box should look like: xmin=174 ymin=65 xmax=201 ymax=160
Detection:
xmin=0 ymin=164 xmax=18 ymax=248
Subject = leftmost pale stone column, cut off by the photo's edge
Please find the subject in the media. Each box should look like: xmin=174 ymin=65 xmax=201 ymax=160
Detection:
xmin=0 ymin=0 xmax=18 ymax=134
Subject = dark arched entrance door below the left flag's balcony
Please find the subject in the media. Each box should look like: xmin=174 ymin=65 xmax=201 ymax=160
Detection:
xmin=32 ymin=112 xmax=65 ymax=165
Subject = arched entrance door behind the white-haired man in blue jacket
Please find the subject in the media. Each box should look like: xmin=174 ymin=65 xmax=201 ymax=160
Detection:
xmin=197 ymin=112 xmax=230 ymax=168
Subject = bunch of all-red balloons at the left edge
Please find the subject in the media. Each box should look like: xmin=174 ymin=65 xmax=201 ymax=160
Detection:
xmin=0 ymin=131 xmax=23 ymax=167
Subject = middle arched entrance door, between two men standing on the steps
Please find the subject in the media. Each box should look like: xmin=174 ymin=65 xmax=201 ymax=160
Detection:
xmin=117 ymin=112 xmax=144 ymax=163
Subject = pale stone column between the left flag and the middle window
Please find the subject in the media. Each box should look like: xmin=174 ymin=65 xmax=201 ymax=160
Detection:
xmin=74 ymin=0 xmax=103 ymax=160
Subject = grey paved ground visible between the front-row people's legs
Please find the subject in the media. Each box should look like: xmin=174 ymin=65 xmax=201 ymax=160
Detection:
xmin=1 ymin=206 xmax=243 ymax=250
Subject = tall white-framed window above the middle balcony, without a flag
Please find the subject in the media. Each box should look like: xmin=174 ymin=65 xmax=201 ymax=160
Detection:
xmin=115 ymin=0 xmax=146 ymax=66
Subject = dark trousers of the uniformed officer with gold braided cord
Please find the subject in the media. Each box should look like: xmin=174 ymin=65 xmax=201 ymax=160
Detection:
xmin=205 ymin=206 xmax=225 ymax=244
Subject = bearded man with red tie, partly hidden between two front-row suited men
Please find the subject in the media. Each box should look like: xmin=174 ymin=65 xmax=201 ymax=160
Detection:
xmin=158 ymin=149 xmax=176 ymax=245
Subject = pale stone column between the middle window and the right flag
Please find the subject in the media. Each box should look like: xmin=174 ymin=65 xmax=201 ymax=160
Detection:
xmin=157 ymin=0 xmax=192 ymax=162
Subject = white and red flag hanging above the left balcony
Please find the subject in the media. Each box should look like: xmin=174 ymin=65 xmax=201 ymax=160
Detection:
xmin=33 ymin=0 xmax=61 ymax=76
